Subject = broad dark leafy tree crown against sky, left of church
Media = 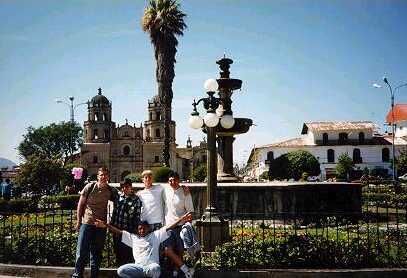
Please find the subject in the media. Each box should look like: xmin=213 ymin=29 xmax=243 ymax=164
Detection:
xmin=17 ymin=122 xmax=82 ymax=164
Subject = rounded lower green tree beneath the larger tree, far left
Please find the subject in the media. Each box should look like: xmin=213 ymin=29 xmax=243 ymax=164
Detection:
xmin=16 ymin=156 xmax=66 ymax=193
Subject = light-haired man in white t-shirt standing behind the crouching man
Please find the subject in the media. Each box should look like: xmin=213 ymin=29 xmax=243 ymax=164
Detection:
xmin=137 ymin=170 xmax=165 ymax=231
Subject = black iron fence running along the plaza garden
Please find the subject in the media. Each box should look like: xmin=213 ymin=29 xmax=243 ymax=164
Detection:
xmin=0 ymin=189 xmax=407 ymax=269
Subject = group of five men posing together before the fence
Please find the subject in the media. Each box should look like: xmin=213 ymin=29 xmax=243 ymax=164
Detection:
xmin=72 ymin=167 xmax=200 ymax=278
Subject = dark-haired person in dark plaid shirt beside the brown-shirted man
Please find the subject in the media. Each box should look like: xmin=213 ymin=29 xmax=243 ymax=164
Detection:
xmin=110 ymin=179 xmax=141 ymax=266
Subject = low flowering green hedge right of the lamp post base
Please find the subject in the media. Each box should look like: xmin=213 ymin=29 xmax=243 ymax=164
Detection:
xmin=203 ymin=235 xmax=407 ymax=269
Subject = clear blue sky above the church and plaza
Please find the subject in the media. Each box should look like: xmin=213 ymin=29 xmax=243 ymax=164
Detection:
xmin=0 ymin=0 xmax=407 ymax=162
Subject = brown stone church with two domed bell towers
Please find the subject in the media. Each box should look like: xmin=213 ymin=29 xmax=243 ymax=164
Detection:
xmin=80 ymin=88 xmax=206 ymax=182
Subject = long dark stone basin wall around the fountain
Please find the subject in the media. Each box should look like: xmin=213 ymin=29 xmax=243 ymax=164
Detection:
xmin=129 ymin=182 xmax=362 ymax=218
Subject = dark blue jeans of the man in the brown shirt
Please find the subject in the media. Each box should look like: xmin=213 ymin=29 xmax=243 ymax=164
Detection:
xmin=72 ymin=224 xmax=106 ymax=278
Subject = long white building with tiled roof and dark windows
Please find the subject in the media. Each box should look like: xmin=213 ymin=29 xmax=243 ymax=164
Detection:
xmin=247 ymin=121 xmax=407 ymax=180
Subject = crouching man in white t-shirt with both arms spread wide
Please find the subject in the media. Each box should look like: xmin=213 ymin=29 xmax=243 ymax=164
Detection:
xmin=96 ymin=213 xmax=193 ymax=278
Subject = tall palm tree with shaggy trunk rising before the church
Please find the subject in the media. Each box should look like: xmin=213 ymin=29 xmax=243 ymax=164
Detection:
xmin=141 ymin=0 xmax=187 ymax=167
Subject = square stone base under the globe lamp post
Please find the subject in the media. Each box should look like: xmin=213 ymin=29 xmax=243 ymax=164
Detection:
xmin=196 ymin=207 xmax=229 ymax=252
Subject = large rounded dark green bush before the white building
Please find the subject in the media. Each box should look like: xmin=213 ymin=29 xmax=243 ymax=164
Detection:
xmin=269 ymin=150 xmax=321 ymax=180
